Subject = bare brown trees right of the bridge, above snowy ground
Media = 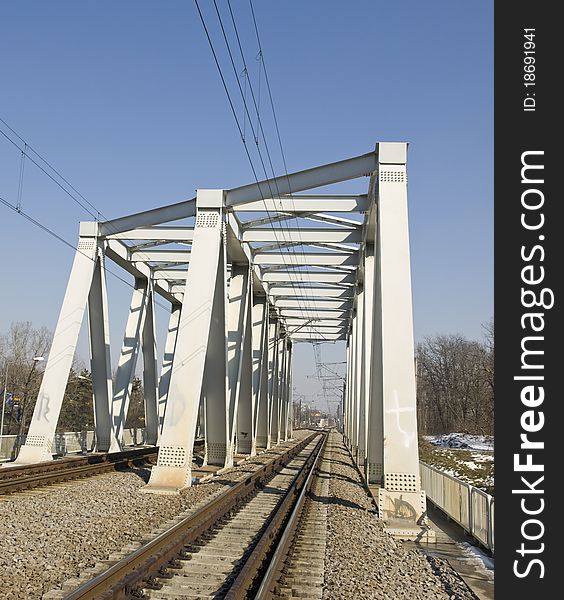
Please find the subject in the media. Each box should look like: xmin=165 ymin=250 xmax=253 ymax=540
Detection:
xmin=416 ymin=320 xmax=494 ymax=435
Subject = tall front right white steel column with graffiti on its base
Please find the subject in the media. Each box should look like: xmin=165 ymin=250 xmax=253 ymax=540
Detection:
xmin=376 ymin=143 xmax=426 ymax=525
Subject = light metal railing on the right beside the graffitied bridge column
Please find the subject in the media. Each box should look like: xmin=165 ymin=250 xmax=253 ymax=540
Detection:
xmin=419 ymin=463 xmax=495 ymax=554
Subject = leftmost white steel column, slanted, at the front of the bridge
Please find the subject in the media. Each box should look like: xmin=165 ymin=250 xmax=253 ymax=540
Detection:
xmin=10 ymin=223 xmax=98 ymax=466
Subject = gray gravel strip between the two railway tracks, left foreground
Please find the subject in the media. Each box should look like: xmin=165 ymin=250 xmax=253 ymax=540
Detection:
xmin=0 ymin=431 xmax=309 ymax=600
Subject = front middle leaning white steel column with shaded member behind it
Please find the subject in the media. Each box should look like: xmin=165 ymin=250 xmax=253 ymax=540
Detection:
xmin=144 ymin=190 xmax=229 ymax=493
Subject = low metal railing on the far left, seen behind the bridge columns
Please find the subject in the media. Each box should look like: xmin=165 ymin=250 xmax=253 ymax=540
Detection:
xmin=0 ymin=427 xmax=145 ymax=460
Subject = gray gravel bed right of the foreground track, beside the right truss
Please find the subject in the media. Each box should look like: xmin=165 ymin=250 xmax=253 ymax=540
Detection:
xmin=323 ymin=433 xmax=476 ymax=600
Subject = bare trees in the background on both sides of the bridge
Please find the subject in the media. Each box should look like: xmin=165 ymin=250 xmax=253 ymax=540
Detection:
xmin=0 ymin=321 xmax=494 ymax=435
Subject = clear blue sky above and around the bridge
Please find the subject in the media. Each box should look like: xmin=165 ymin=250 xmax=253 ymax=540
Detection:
xmin=0 ymin=0 xmax=493 ymax=412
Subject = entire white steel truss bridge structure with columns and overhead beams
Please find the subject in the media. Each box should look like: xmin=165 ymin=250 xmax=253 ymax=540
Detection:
xmin=12 ymin=142 xmax=425 ymax=523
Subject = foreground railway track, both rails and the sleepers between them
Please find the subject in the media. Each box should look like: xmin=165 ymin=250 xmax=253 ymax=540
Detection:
xmin=57 ymin=434 xmax=326 ymax=600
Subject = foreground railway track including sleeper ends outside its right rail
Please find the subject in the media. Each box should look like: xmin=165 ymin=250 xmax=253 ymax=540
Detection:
xmin=55 ymin=433 xmax=327 ymax=600
